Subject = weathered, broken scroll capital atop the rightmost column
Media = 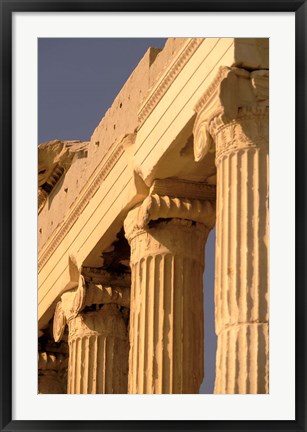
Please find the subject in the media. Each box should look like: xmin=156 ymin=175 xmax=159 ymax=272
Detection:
xmin=193 ymin=67 xmax=269 ymax=163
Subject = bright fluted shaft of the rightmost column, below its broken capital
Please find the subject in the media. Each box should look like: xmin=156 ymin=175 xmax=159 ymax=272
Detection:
xmin=215 ymin=108 xmax=269 ymax=393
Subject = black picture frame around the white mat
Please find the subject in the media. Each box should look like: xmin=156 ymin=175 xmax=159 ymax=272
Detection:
xmin=0 ymin=0 xmax=307 ymax=432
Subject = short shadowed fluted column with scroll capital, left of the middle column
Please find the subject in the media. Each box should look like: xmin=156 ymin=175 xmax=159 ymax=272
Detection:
xmin=53 ymin=276 xmax=130 ymax=394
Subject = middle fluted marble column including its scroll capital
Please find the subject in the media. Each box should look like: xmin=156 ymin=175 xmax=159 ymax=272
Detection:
xmin=125 ymin=177 xmax=215 ymax=394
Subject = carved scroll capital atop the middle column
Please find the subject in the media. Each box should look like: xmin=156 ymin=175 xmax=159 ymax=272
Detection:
xmin=124 ymin=179 xmax=215 ymax=242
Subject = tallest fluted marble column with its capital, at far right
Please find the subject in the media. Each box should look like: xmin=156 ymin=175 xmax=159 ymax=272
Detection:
xmin=194 ymin=68 xmax=269 ymax=394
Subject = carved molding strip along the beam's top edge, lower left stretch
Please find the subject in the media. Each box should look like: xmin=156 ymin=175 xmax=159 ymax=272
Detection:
xmin=38 ymin=135 xmax=129 ymax=271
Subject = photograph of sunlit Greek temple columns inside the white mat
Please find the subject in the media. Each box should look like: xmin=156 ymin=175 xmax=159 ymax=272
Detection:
xmin=38 ymin=37 xmax=270 ymax=395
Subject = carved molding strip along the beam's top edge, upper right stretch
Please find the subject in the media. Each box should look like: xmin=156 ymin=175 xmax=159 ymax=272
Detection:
xmin=138 ymin=38 xmax=204 ymax=127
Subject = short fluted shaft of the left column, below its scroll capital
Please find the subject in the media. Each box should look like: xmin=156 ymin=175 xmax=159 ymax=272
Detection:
xmin=67 ymin=305 xmax=129 ymax=394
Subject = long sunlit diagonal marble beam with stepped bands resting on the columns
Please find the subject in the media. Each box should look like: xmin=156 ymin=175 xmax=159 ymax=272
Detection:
xmin=38 ymin=38 xmax=268 ymax=326
